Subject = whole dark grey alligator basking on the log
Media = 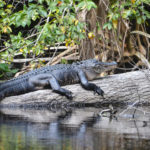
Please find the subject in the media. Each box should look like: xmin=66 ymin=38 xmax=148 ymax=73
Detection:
xmin=0 ymin=59 xmax=117 ymax=100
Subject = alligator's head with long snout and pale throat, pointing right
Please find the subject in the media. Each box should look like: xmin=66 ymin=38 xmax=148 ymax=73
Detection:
xmin=76 ymin=59 xmax=117 ymax=80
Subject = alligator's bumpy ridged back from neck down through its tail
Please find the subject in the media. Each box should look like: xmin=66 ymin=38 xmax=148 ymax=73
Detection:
xmin=0 ymin=59 xmax=95 ymax=99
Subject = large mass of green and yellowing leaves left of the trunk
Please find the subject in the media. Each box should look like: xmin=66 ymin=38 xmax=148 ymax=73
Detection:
xmin=0 ymin=0 xmax=96 ymax=62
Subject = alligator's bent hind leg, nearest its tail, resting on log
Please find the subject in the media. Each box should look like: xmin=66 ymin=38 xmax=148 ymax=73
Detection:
xmin=29 ymin=74 xmax=73 ymax=100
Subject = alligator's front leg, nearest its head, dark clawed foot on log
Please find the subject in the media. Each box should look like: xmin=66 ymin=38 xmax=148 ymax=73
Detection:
xmin=78 ymin=70 xmax=104 ymax=96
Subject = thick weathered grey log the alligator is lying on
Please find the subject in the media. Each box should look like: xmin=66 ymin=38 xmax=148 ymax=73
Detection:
xmin=0 ymin=70 xmax=150 ymax=107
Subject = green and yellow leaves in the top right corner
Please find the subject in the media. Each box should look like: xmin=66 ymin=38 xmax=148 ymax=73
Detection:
xmin=103 ymin=0 xmax=150 ymax=30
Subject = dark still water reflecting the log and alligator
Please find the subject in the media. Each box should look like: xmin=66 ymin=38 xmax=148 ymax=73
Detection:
xmin=0 ymin=107 xmax=150 ymax=150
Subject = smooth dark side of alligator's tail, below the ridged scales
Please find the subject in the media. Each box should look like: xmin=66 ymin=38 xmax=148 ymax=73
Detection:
xmin=0 ymin=81 xmax=34 ymax=100
